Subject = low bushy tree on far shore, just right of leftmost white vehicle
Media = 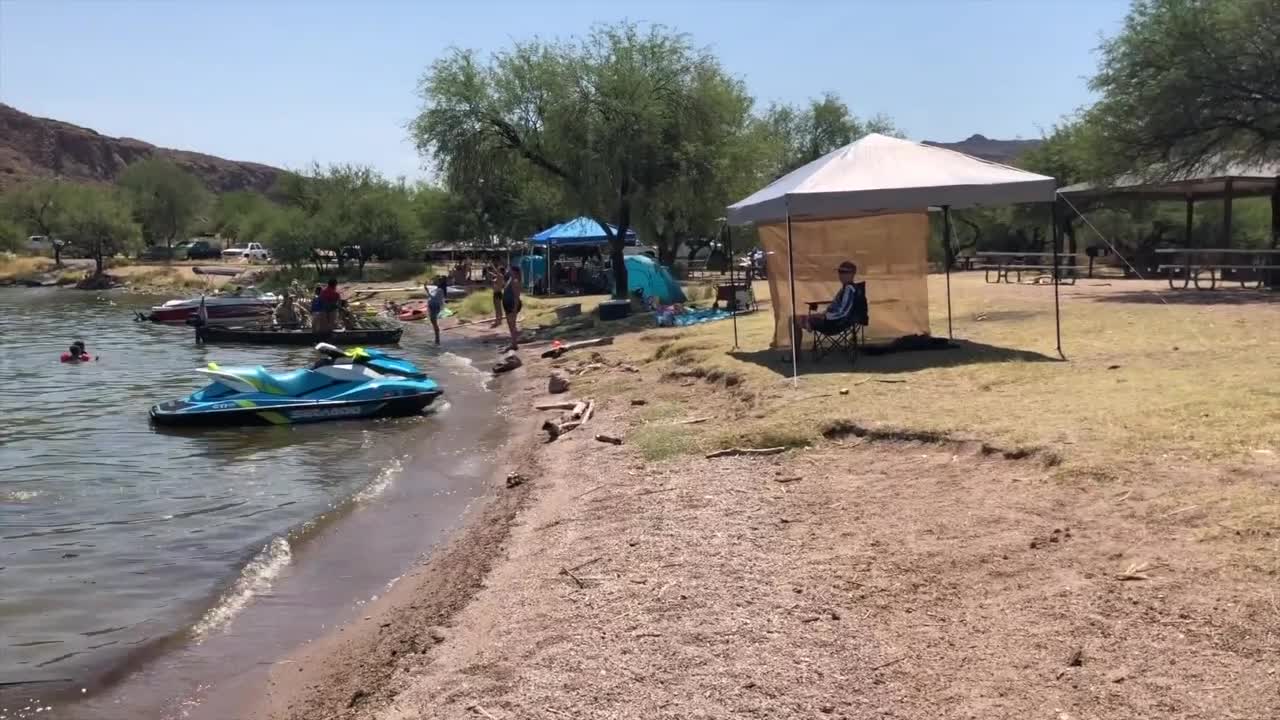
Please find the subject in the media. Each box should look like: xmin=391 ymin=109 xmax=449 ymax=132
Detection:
xmin=63 ymin=186 xmax=142 ymax=277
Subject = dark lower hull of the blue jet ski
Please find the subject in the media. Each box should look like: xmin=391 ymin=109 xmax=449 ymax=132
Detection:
xmin=151 ymin=389 xmax=442 ymax=427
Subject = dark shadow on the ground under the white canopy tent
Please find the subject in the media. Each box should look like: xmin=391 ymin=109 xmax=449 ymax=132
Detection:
xmin=730 ymin=340 xmax=1064 ymax=375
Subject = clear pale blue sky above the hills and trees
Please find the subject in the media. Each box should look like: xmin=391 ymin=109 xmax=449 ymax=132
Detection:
xmin=0 ymin=0 xmax=1128 ymax=178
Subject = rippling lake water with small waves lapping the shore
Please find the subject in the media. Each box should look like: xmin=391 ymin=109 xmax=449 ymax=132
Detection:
xmin=0 ymin=288 xmax=503 ymax=717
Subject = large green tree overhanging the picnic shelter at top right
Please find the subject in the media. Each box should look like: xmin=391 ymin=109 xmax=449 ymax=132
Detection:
xmin=1088 ymin=0 xmax=1280 ymax=177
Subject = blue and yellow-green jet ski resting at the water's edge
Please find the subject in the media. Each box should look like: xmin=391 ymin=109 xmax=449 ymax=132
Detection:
xmin=151 ymin=342 xmax=443 ymax=425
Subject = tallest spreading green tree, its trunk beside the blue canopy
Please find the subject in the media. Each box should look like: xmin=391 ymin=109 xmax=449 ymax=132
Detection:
xmin=412 ymin=23 xmax=742 ymax=296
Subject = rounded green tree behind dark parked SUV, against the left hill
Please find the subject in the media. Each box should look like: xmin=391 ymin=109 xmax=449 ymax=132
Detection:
xmin=116 ymin=158 xmax=209 ymax=256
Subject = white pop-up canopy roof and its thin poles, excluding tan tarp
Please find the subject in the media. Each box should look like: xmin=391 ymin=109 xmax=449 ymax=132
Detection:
xmin=727 ymin=133 xmax=1061 ymax=372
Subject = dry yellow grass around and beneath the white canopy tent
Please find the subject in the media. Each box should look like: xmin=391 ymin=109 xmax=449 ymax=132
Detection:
xmin=570 ymin=274 xmax=1280 ymax=466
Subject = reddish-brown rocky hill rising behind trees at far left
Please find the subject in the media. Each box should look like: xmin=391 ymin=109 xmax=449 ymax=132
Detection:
xmin=0 ymin=102 xmax=283 ymax=192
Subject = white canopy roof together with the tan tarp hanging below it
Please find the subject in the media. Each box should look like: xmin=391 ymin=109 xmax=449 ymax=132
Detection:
xmin=727 ymin=135 xmax=1057 ymax=364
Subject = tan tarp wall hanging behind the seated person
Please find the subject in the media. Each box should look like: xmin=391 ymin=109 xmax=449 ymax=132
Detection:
xmin=756 ymin=211 xmax=929 ymax=347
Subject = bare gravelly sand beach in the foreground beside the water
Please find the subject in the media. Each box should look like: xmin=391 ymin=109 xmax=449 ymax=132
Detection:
xmin=232 ymin=283 xmax=1280 ymax=720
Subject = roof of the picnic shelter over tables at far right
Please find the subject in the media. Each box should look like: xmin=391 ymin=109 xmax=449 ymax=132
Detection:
xmin=1059 ymin=163 xmax=1280 ymax=200
